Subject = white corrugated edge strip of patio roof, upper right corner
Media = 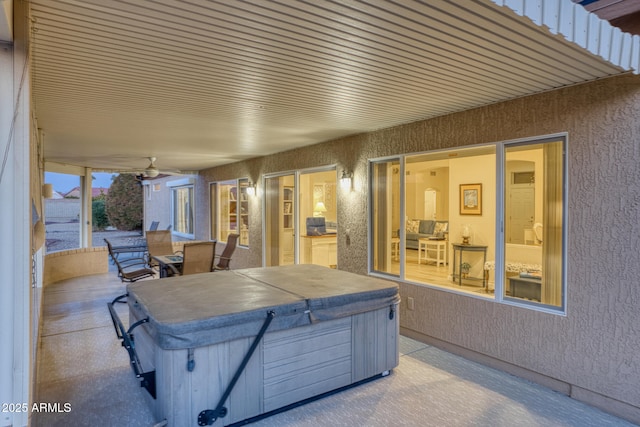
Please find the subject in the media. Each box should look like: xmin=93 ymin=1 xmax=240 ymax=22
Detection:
xmin=490 ymin=0 xmax=640 ymax=74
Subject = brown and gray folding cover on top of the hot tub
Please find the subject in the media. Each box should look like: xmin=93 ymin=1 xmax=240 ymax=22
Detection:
xmin=127 ymin=265 xmax=399 ymax=349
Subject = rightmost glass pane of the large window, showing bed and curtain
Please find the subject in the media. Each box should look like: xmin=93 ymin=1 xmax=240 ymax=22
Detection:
xmin=504 ymin=140 xmax=565 ymax=307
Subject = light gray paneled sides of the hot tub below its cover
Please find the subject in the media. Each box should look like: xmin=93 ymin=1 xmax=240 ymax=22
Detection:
xmin=136 ymin=307 xmax=399 ymax=426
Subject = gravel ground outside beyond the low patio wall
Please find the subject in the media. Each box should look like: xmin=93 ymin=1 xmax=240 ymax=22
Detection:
xmin=46 ymin=221 xmax=145 ymax=253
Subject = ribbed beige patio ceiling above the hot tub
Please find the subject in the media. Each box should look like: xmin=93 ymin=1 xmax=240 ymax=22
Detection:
xmin=31 ymin=0 xmax=632 ymax=174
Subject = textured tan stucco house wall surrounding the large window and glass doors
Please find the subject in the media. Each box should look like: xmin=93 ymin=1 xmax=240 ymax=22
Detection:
xmin=149 ymin=76 xmax=640 ymax=422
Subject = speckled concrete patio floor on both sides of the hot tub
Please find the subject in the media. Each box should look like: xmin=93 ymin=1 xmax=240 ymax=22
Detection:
xmin=31 ymin=266 xmax=634 ymax=427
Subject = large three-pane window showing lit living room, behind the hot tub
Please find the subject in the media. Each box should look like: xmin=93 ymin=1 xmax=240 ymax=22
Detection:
xmin=370 ymin=137 xmax=566 ymax=311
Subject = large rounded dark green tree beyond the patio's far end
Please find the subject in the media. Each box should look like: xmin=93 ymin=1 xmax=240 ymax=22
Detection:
xmin=106 ymin=174 xmax=143 ymax=231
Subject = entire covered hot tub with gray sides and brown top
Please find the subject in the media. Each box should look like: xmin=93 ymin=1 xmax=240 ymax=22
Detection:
xmin=114 ymin=265 xmax=399 ymax=426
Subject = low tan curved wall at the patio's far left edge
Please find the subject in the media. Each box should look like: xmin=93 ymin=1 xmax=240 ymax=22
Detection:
xmin=43 ymin=247 xmax=109 ymax=286
